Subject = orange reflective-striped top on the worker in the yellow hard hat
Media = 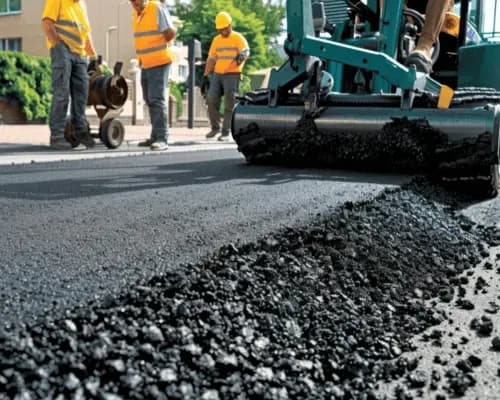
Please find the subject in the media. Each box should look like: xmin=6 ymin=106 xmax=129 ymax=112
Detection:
xmin=208 ymin=31 xmax=248 ymax=74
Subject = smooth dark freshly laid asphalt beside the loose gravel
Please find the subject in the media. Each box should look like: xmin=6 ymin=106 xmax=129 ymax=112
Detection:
xmin=0 ymin=149 xmax=408 ymax=323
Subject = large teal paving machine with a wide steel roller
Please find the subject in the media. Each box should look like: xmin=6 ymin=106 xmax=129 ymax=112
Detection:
xmin=232 ymin=0 xmax=500 ymax=197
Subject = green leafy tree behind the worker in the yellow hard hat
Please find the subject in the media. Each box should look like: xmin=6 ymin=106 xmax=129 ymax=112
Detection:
xmin=175 ymin=0 xmax=285 ymax=71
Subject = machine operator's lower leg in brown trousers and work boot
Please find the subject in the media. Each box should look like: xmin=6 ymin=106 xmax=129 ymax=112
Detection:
xmin=405 ymin=0 xmax=454 ymax=74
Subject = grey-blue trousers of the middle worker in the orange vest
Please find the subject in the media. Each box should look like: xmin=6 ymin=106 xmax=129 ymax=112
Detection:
xmin=141 ymin=64 xmax=170 ymax=143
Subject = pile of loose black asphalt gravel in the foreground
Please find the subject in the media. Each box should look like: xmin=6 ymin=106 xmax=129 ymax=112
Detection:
xmin=0 ymin=186 xmax=500 ymax=400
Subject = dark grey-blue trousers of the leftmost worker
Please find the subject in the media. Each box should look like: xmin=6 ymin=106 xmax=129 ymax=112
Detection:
xmin=49 ymin=42 xmax=89 ymax=139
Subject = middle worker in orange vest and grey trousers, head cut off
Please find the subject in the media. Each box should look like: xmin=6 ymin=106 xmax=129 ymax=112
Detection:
xmin=130 ymin=0 xmax=176 ymax=150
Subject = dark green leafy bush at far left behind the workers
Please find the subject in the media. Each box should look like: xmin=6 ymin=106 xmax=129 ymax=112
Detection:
xmin=0 ymin=51 xmax=52 ymax=121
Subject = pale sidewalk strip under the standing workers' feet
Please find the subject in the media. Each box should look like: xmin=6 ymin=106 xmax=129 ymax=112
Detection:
xmin=0 ymin=125 xmax=237 ymax=165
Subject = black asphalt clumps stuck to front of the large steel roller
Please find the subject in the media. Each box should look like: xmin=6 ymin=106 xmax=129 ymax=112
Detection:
xmin=265 ymin=114 xmax=446 ymax=172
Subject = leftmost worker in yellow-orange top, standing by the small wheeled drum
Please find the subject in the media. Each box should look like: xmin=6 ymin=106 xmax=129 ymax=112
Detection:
xmin=42 ymin=0 xmax=96 ymax=150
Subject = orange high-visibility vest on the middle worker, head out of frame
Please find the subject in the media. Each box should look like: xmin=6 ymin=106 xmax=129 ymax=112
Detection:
xmin=133 ymin=1 xmax=172 ymax=68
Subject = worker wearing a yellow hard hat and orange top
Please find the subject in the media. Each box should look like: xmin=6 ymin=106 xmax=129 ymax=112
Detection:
xmin=202 ymin=11 xmax=250 ymax=140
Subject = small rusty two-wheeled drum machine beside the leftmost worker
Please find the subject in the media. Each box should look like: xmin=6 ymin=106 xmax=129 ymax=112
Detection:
xmin=64 ymin=61 xmax=128 ymax=149
